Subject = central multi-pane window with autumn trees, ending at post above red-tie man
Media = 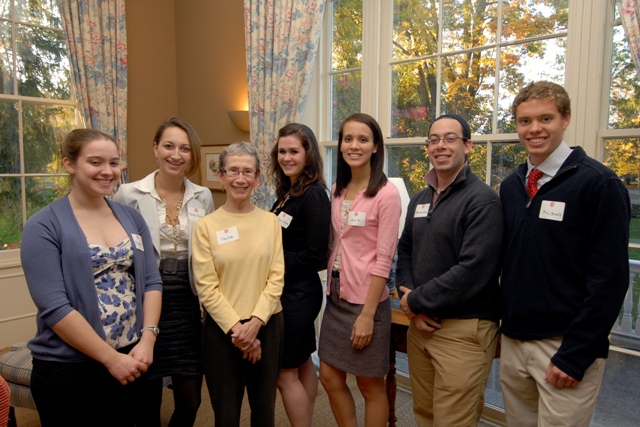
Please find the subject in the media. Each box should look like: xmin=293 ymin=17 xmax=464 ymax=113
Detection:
xmin=320 ymin=0 xmax=569 ymax=194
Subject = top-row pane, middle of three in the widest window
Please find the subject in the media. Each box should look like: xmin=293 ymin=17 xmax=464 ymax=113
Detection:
xmin=436 ymin=0 xmax=498 ymax=52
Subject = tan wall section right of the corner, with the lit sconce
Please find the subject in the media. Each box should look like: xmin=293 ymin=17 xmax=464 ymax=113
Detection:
xmin=176 ymin=0 xmax=249 ymax=206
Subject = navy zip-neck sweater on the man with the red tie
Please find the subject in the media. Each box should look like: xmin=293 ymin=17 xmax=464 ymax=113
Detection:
xmin=500 ymin=147 xmax=631 ymax=381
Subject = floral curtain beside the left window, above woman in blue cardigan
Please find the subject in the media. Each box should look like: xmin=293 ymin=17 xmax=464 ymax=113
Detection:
xmin=59 ymin=0 xmax=128 ymax=182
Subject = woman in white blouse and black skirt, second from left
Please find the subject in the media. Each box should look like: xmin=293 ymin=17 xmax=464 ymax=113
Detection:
xmin=114 ymin=118 xmax=213 ymax=426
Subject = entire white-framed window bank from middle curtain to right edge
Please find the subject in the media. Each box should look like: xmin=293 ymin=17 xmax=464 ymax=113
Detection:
xmin=318 ymin=0 xmax=640 ymax=425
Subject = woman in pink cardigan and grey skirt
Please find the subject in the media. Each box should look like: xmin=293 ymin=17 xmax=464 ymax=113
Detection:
xmin=319 ymin=114 xmax=401 ymax=427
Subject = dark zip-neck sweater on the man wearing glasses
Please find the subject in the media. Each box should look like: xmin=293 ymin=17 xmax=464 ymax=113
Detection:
xmin=396 ymin=165 xmax=503 ymax=320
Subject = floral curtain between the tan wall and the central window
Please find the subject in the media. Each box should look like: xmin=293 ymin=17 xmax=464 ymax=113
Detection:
xmin=244 ymin=0 xmax=325 ymax=209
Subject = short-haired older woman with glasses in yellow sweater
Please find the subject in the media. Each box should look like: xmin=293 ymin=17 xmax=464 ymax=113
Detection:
xmin=192 ymin=142 xmax=284 ymax=426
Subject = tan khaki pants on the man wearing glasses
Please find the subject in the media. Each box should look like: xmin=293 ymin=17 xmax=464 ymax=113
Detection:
xmin=407 ymin=319 xmax=498 ymax=427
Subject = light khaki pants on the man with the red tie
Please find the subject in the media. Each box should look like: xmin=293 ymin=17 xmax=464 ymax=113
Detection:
xmin=500 ymin=335 xmax=605 ymax=427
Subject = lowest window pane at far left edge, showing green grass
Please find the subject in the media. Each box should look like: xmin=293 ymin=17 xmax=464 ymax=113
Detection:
xmin=0 ymin=177 xmax=22 ymax=250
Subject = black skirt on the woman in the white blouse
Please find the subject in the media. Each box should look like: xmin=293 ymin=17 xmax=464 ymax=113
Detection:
xmin=148 ymin=271 xmax=202 ymax=378
